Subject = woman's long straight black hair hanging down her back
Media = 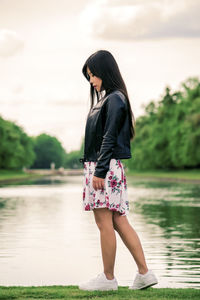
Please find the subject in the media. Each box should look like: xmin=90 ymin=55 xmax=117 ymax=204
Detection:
xmin=82 ymin=50 xmax=135 ymax=139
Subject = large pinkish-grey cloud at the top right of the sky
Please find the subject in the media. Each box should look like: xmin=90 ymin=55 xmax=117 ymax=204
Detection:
xmin=82 ymin=0 xmax=200 ymax=40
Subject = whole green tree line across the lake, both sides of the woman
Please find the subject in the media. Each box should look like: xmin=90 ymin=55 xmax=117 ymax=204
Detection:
xmin=0 ymin=78 xmax=200 ymax=170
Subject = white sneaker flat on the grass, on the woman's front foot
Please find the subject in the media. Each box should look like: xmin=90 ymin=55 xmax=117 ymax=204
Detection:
xmin=79 ymin=272 xmax=118 ymax=291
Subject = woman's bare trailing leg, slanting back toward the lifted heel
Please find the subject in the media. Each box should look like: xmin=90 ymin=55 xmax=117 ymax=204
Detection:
xmin=113 ymin=211 xmax=148 ymax=274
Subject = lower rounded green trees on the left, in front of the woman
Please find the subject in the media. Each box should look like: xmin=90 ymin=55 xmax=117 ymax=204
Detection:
xmin=0 ymin=117 xmax=80 ymax=170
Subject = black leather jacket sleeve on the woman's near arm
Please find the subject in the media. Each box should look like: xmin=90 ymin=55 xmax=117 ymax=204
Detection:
xmin=94 ymin=94 xmax=125 ymax=178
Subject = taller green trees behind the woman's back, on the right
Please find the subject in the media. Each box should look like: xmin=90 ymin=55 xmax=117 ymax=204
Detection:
xmin=127 ymin=78 xmax=200 ymax=170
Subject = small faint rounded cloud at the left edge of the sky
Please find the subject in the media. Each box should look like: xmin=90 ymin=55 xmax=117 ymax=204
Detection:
xmin=0 ymin=29 xmax=24 ymax=57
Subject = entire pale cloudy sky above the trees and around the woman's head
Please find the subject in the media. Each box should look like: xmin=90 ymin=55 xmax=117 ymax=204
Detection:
xmin=0 ymin=0 xmax=200 ymax=152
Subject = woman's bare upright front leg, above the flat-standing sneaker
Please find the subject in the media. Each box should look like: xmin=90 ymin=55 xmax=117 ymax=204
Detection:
xmin=93 ymin=208 xmax=116 ymax=279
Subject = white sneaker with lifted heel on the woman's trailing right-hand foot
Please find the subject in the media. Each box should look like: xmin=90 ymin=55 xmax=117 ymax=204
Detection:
xmin=129 ymin=270 xmax=158 ymax=290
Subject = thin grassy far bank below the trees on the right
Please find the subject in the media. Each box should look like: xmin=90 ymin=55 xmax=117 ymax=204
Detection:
xmin=126 ymin=169 xmax=200 ymax=181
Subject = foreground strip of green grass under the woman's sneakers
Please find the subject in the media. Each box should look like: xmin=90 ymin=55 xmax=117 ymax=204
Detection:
xmin=0 ymin=285 xmax=200 ymax=300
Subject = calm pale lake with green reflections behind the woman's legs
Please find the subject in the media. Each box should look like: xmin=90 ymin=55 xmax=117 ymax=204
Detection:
xmin=0 ymin=176 xmax=200 ymax=288
